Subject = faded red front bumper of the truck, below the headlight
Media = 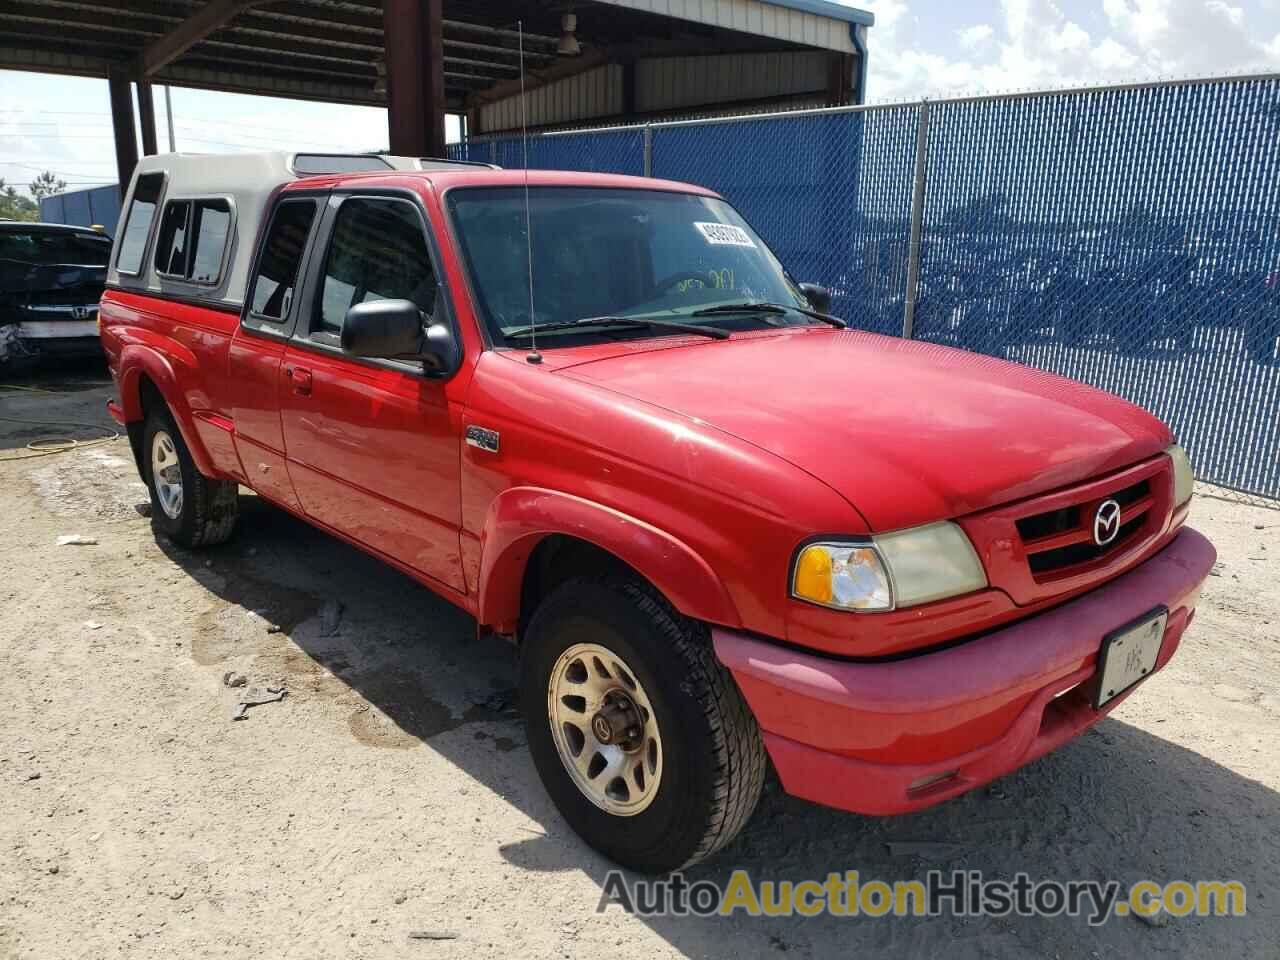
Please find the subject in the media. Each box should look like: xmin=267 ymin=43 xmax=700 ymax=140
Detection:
xmin=712 ymin=529 xmax=1216 ymax=814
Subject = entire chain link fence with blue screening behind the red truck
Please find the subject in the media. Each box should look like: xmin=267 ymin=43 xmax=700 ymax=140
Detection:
xmin=451 ymin=76 xmax=1280 ymax=500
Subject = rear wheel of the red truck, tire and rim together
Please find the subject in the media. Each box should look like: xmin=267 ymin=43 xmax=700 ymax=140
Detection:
xmin=142 ymin=408 xmax=239 ymax=547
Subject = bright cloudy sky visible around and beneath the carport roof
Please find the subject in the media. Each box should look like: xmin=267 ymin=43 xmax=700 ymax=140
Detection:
xmin=0 ymin=0 xmax=1280 ymax=199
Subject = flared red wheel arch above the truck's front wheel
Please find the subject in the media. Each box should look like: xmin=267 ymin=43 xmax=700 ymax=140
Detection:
xmin=477 ymin=486 xmax=740 ymax=632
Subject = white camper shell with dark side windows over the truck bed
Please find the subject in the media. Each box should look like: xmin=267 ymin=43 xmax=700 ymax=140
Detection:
xmin=106 ymin=151 xmax=489 ymax=311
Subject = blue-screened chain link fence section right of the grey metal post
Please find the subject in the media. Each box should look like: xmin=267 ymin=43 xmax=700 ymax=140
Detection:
xmin=914 ymin=81 xmax=1280 ymax=497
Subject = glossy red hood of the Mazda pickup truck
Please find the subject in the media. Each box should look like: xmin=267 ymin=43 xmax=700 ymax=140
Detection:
xmin=558 ymin=328 xmax=1172 ymax=531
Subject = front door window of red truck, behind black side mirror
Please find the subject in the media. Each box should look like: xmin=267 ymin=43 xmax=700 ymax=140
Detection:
xmin=316 ymin=197 xmax=436 ymax=335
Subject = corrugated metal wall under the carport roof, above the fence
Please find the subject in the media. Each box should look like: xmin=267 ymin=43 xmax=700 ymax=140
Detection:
xmin=475 ymin=50 xmax=831 ymax=133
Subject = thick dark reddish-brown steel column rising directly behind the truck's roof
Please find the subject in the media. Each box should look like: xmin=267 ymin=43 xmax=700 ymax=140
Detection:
xmin=383 ymin=0 xmax=445 ymax=156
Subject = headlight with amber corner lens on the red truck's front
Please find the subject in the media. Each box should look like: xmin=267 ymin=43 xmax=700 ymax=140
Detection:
xmin=791 ymin=522 xmax=987 ymax=611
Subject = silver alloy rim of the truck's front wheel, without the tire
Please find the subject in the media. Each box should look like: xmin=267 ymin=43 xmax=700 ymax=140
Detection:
xmin=547 ymin=644 xmax=663 ymax=817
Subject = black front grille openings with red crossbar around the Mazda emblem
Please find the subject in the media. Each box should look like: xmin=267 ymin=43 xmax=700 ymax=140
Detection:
xmin=1016 ymin=480 xmax=1155 ymax=581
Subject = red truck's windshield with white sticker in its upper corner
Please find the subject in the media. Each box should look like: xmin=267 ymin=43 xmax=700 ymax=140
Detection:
xmin=448 ymin=187 xmax=812 ymax=347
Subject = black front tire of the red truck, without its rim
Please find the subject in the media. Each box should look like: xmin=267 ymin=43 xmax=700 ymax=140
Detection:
xmin=520 ymin=580 xmax=767 ymax=873
